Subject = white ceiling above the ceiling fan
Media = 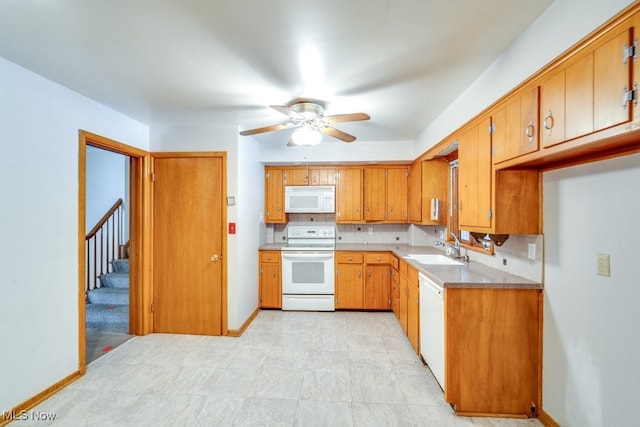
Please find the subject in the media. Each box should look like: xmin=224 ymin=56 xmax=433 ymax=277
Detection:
xmin=0 ymin=0 xmax=553 ymax=144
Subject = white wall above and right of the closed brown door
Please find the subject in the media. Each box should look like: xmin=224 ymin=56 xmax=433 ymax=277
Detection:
xmin=151 ymin=125 xmax=263 ymax=329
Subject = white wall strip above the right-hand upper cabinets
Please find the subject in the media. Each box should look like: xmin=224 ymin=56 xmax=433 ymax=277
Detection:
xmin=414 ymin=0 xmax=633 ymax=157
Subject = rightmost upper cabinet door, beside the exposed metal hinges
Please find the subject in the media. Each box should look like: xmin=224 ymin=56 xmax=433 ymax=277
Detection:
xmin=593 ymin=27 xmax=633 ymax=131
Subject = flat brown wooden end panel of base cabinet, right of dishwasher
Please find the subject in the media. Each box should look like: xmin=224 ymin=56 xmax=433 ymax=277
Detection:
xmin=444 ymin=288 xmax=542 ymax=417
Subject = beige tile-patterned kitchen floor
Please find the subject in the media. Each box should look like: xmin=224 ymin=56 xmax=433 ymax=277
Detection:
xmin=20 ymin=311 xmax=541 ymax=427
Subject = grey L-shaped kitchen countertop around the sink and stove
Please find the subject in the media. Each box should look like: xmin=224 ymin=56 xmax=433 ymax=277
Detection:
xmin=260 ymin=243 xmax=542 ymax=289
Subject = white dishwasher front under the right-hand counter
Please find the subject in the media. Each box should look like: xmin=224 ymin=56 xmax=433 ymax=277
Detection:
xmin=418 ymin=273 xmax=444 ymax=390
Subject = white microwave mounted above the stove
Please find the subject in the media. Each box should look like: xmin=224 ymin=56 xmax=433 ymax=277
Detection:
xmin=284 ymin=185 xmax=336 ymax=213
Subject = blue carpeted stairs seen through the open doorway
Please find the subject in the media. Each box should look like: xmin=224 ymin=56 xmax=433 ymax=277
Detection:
xmin=86 ymin=258 xmax=129 ymax=334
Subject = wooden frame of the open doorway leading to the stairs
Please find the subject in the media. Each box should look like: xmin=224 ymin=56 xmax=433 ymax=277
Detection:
xmin=78 ymin=129 xmax=153 ymax=374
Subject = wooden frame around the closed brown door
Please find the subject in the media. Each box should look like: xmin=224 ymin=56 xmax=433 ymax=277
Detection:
xmin=147 ymin=151 xmax=229 ymax=336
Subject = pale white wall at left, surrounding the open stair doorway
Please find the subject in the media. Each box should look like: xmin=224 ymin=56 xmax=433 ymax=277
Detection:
xmin=0 ymin=58 xmax=148 ymax=410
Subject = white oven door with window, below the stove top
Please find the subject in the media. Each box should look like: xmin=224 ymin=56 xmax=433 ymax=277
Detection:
xmin=282 ymin=250 xmax=335 ymax=295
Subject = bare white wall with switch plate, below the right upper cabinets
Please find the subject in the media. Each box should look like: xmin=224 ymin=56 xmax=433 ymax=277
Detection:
xmin=543 ymin=154 xmax=640 ymax=427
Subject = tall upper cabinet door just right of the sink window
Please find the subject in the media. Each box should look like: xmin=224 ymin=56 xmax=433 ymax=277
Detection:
xmin=458 ymin=119 xmax=492 ymax=231
